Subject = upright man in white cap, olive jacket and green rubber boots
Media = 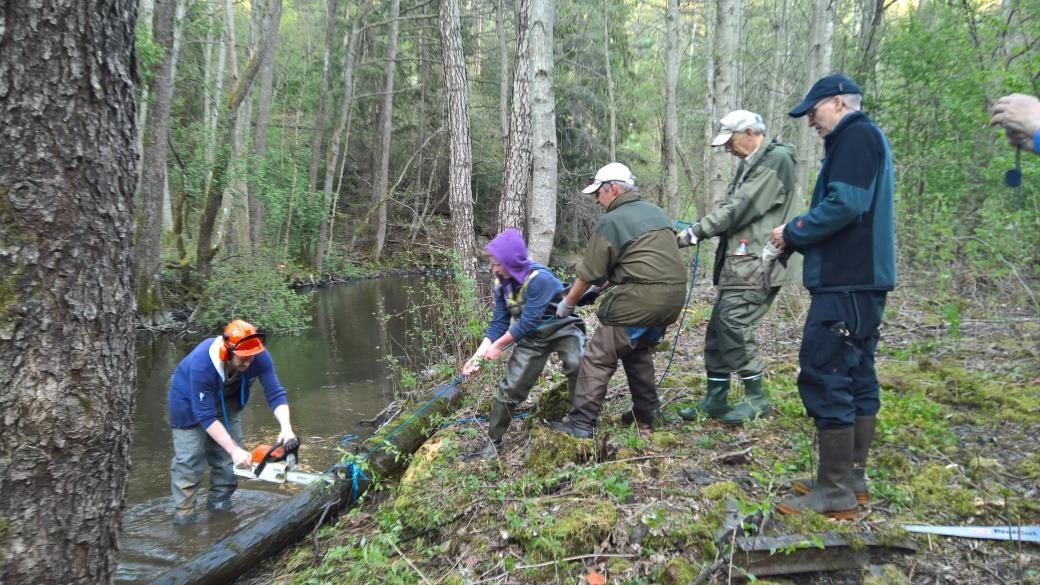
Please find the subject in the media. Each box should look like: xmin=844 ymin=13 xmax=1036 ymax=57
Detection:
xmin=679 ymin=109 xmax=798 ymax=425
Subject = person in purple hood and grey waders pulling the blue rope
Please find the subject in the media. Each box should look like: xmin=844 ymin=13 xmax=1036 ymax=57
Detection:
xmin=463 ymin=229 xmax=586 ymax=457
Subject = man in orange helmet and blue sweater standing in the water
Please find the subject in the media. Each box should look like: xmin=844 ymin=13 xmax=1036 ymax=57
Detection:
xmin=166 ymin=320 xmax=296 ymax=525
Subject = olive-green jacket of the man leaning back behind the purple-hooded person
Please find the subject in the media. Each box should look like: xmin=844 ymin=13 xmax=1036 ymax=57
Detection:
xmin=577 ymin=192 xmax=686 ymax=327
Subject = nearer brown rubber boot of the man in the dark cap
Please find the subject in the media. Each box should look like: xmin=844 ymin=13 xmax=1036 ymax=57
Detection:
xmin=777 ymin=427 xmax=857 ymax=520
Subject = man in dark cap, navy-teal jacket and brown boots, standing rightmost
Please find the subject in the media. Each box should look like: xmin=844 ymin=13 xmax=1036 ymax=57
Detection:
xmin=771 ymin=74 xmax=895 ymax=518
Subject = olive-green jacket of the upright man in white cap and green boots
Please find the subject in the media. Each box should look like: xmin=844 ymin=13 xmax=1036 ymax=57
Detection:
xmin=680 ymin=139 xmax=801 ymax=289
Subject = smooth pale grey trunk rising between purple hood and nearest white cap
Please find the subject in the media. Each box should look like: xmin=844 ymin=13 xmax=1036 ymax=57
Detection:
xmin=527 ymin=0 xmax=556 ymax=264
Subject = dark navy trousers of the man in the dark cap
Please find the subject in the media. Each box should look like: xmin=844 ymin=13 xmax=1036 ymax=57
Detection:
xmin=798 ymin=290 xmax=887 ymax=429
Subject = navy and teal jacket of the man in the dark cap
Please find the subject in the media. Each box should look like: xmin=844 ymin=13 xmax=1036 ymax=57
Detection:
xmin=783 ymin=111 xmax=895 ymax=294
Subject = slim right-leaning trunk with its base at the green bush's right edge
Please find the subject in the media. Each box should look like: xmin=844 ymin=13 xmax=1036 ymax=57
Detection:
xmin=324 ymin=0 xmax=372 ymax=272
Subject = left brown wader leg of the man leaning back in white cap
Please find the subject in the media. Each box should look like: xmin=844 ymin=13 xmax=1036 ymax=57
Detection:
xmin=568 ymin=325 xmax=629 ymax=430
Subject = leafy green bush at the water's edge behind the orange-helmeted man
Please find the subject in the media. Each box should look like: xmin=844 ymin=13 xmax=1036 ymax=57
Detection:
xmin=197 ymin=251 xmax=310 ymax=333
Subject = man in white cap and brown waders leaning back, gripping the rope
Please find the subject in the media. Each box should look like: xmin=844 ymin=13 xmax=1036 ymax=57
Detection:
xmin=550 ymin=162 xmax=686 ymax=438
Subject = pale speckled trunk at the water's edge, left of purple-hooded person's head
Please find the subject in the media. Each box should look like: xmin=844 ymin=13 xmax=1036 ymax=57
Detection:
xmin=438 ymin=0 xmax=476 ymax=276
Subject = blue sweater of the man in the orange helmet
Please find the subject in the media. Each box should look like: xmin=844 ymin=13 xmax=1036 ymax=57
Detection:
xmin=166 ymin=337 xmax=289 ymax=429
